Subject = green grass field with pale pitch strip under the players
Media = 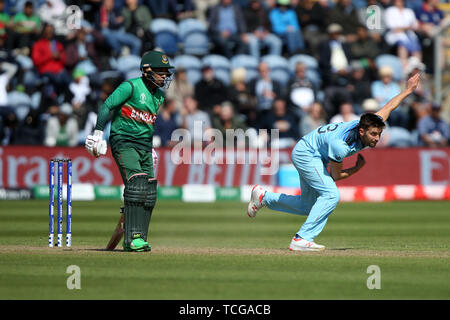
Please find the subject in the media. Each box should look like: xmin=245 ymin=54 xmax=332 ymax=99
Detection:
xmin=0 ymin=200 xmax=450 ymax=300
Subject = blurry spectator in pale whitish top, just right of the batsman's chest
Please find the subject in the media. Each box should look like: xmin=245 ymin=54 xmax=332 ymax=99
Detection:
xmin=181 ymin=96 xmax=211 ymax=144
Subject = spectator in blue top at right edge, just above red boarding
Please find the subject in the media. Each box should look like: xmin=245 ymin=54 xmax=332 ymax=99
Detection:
xmin=417 ymin=103 xmax=450 ymax=147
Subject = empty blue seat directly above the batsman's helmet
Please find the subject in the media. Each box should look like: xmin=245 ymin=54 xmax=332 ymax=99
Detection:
xmin=150 ymin=18 xmax=178 ymax=56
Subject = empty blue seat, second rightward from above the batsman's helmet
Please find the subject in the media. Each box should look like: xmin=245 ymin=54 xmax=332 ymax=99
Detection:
xmin=178 ymin=19 xmax=210 ymax=56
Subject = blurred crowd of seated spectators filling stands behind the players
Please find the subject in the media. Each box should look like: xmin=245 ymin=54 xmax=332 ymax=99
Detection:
xmin=0 ymin=0 xmax=450 ymax=147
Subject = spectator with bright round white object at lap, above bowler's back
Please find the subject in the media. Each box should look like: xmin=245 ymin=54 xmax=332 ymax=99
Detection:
xmin=287 ymin=62 xmax=316 ymax=117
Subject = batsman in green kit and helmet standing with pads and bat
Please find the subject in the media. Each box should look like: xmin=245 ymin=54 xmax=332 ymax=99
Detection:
xmin=85 ymin=51 xmax=173 ymax=251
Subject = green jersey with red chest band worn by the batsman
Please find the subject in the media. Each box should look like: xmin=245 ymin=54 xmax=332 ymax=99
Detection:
xmin=95 ymin=77 xmax=164 ymax=151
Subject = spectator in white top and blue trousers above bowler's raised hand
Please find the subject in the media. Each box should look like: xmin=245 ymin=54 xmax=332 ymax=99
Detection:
xmin=384 ymin=0 xmax=422 ymax=66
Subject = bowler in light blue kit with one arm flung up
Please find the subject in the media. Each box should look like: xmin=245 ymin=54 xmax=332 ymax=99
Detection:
xmin=247 ymin=73 xmax=420 ymax=251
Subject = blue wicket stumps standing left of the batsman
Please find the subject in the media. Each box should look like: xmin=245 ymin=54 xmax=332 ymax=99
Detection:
xmin=48 ymin=159 xmax=72 ymax=248
